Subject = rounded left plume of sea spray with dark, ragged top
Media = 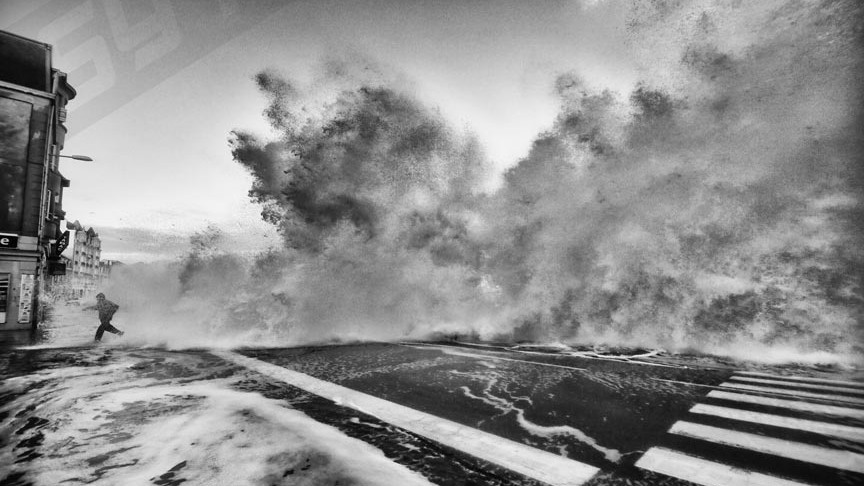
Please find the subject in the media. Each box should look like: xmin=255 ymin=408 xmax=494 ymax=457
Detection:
xmin=224 ymin=64 xmax=506 ymax=339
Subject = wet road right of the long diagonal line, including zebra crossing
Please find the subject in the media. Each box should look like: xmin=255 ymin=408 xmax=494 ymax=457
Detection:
xmin=240 ymin=343 xmax=864 ymax=485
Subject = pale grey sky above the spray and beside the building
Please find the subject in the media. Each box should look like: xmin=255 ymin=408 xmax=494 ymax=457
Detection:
xmin=0 ymin=0 xmax=637 ymax=262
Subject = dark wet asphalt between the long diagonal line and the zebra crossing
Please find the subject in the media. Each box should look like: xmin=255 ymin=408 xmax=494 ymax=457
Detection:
xmin=238 ymin=344 xmax=731 ymax=467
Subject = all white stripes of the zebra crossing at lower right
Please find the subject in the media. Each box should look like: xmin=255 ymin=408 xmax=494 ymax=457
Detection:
xmin=636 ymin=372 xmax=864 ymax=486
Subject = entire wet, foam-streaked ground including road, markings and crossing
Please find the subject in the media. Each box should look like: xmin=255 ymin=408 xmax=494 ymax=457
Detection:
xmin=0 ymin=318 xmax=864 ymax=486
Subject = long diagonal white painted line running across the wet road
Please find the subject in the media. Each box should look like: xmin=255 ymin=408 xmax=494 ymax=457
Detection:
xmin=213 ymin=351 xmax=599 ymax=486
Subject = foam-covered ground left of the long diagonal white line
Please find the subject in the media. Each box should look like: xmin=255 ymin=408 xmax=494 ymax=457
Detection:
xmin=0 ymin=346 xmax=572 ymax=485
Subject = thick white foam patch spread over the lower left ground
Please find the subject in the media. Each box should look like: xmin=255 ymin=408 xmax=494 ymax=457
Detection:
xmin=0 ymin=349 xmax=429 ymax=486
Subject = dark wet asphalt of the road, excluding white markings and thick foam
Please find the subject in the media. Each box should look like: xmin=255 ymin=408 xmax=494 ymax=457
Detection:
xmin=0 ymin=343 xmax=864 ymax=485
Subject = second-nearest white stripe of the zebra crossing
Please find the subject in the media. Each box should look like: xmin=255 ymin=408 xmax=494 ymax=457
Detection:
xmin=669 ymin=422 xmax=864 ymax=474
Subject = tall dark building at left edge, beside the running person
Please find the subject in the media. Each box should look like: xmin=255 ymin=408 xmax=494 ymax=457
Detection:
xmin=0 ymin=31 xmax=76 ymax=330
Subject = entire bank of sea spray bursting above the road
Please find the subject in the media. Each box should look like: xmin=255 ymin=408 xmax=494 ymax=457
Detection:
xmin=99 ymin=1 xmax=864 ymax=356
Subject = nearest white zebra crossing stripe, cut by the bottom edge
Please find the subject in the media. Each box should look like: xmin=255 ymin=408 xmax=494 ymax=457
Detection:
xmin=636 ymin=447 xmax=805 ymax=486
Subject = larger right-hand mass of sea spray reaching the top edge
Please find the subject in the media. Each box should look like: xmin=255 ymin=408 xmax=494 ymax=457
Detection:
xmin=482 ymin=2 xmax=862 ymax=352
